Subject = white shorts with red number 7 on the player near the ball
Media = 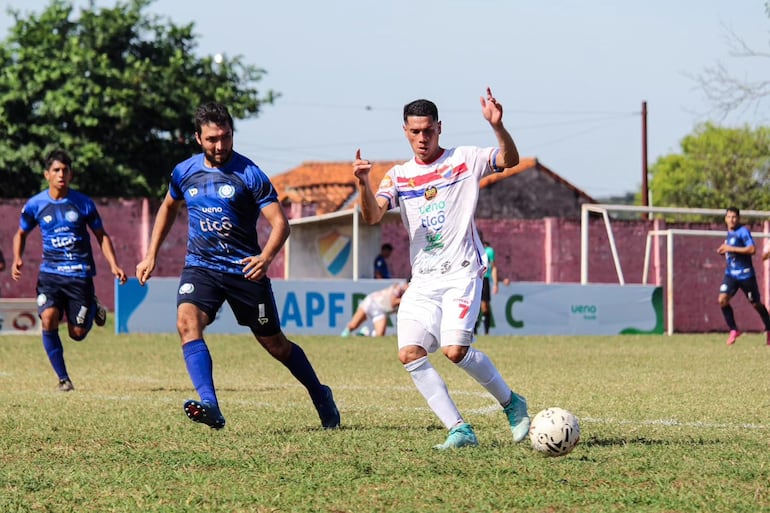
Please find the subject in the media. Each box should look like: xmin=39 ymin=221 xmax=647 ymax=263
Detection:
xmin=397 ymin=276 xmax=481 ymax=353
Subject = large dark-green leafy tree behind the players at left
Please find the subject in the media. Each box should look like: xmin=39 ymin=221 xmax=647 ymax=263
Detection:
xmin=0 ymin=0 xmax=278 ymax=198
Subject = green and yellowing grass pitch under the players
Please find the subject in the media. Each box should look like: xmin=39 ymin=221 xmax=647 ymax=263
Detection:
xmin=0 ymin=324 xmax=770 ymax=513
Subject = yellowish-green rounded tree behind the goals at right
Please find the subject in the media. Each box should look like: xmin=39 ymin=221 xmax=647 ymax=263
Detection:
xmin=650 ymin=123 xmax=770 ymax=210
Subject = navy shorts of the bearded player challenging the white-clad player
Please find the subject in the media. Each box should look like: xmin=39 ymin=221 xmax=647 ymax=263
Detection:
xmin=176 ymin=267 xmax=281 ymax=337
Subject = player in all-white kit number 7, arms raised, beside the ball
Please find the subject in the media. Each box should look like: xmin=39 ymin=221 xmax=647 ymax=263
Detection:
xmin=353 ymin=88 xmax=529 ymax=449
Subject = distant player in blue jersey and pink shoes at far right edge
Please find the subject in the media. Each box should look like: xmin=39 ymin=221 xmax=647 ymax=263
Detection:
xmin=717 ymin=207 xmax=770 ymax=346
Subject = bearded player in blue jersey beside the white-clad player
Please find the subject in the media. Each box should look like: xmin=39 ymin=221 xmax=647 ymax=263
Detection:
xmin=136 ymin=102 xmax=340 ymax=429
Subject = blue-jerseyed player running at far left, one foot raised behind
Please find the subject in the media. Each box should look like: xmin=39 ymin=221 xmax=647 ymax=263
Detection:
xmin=11 ymin=150 xmax=126 ymax=392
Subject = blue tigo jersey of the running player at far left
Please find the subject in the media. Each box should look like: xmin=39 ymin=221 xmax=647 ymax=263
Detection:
xmin=19 ymin=189 xmax=103 ymax=278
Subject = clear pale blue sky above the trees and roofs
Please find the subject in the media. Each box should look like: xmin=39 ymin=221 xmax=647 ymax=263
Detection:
xmin=0 ymin=0 xmax=770 ymax=198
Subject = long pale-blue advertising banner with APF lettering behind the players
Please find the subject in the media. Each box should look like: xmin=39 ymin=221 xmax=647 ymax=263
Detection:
xmin=115 ymin=278 xmax=664 ymax=335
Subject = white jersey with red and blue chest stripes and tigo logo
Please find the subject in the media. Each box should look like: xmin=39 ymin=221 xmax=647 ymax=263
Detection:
xmin=376 ymin=146 xmax=499 ymax=282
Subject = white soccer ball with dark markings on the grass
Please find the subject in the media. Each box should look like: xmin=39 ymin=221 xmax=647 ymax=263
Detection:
xmin=529 ymin=408 xmax=580 ymax=456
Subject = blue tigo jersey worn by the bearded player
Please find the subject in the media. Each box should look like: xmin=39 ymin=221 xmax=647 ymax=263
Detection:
xmin=169 ymin=152 xmax=278 ymax=274
